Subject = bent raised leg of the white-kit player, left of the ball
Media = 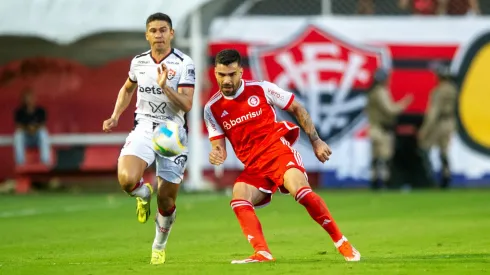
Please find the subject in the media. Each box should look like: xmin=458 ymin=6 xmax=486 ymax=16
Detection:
xmin=117 ymin=124 xmax=155 ymax=223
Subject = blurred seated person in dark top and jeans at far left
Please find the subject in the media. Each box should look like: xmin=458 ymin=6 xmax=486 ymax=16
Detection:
xmin=14 ymin=89 xmax=51 ymax=165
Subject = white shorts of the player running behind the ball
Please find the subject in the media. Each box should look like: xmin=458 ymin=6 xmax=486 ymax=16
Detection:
xmin=119 ymin=119 xmax=188 ymax=184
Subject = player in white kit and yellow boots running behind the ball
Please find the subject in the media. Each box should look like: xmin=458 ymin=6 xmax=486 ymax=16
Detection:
xmin=103 ymin=13 xmax=195 ymax=264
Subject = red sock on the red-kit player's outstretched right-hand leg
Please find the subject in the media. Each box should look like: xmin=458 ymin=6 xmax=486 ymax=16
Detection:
xmin=294 ymin=187 xmax=343 ymax=242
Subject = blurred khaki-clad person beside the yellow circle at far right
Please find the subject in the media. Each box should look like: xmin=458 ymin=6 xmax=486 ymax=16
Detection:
xmin=418 ymin=65 xmax=457 ymax=188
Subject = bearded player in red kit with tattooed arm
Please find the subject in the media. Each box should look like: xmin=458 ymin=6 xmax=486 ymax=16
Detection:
xmin=204 ymin=49 xmax=361 ymax=264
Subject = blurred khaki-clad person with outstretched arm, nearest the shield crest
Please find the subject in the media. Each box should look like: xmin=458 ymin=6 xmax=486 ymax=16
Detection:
xmin=366 ymin=69 xmax=413 ymax=190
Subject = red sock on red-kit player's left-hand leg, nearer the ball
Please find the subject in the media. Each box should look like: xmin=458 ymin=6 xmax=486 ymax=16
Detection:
xmin=230 ymin=200 xmax=270 ymax=252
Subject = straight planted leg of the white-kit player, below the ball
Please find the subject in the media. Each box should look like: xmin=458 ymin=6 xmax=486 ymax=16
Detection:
xmin=150 ymin=153 xmax=187 ymax=264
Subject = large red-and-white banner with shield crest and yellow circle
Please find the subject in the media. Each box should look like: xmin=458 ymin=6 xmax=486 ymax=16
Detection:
xmin=208 ymin=17 xmax=490 ymax=187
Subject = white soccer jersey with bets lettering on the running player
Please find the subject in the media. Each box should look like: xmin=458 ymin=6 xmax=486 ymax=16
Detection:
xmin=129 ymin=48 xmax=196 ymax=125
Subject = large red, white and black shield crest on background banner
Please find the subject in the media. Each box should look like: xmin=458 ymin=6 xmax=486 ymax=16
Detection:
xmin=250 ymin=25 xmax=391 ymax=142
